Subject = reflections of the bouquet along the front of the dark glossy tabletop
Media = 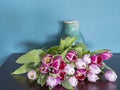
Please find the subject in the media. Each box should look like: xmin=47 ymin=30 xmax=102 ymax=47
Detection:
xmin=13 ymin=75 xmax=117 ymax=90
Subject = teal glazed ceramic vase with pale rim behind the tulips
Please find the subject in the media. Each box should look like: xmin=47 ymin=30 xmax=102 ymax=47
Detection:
xmin=62 ymin=21 xmax=84 ymax=44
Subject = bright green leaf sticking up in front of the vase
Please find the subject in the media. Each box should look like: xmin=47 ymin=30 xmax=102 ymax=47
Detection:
xmin=60 ymin=37 xmax=77 ymax=50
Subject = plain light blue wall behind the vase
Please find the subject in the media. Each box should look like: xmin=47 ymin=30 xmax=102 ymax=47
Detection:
xmin=0 ymin=0 xmax=120 ymax=64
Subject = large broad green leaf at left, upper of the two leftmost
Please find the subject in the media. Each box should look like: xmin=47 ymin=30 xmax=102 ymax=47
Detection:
xmin=16 ymin=49 xmax=44 ymax=64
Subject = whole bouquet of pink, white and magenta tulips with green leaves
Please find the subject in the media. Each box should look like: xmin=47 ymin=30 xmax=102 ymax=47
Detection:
xmin=12 ymin=37 xmax=117 ymax=89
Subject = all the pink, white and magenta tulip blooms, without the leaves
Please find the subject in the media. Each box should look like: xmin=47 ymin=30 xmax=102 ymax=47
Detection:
xmin=27 ymin=50 xmax=117 ymax=88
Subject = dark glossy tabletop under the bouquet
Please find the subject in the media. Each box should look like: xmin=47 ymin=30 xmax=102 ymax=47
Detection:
xmin=0 ymin=53 xmax=120 ymax=90
